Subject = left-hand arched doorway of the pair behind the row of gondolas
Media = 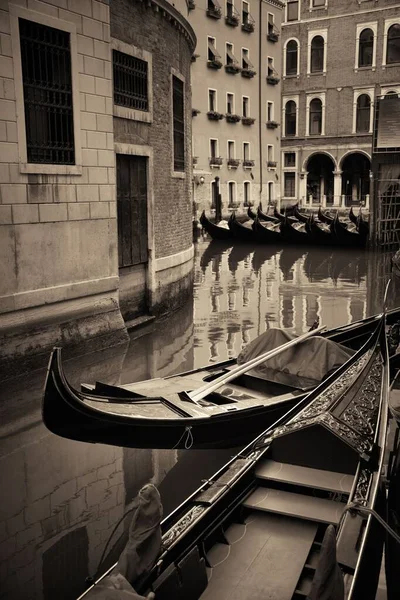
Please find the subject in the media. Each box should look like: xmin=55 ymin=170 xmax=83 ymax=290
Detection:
xmin=306 ymin=154 xmax=335 ymax=205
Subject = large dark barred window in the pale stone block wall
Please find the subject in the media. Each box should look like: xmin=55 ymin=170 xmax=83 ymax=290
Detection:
xmin=19 ymin=19 xmax=75 ymax=165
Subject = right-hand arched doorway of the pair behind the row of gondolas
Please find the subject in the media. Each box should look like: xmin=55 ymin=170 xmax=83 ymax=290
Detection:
xmin=341 ymin=152 xmax=371 ymax=206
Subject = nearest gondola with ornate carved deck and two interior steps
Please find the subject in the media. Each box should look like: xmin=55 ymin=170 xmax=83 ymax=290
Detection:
xmin=79 ymin=318 xmax=388 ymax=600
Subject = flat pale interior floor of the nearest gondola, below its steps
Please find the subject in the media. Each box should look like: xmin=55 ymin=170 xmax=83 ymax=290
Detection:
xmin=201 ymin=511 xmax=318 ymax=600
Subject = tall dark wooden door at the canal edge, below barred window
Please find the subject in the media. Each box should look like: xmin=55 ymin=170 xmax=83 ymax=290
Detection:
xmin=117 ymin=154 xmax=148 ymax=268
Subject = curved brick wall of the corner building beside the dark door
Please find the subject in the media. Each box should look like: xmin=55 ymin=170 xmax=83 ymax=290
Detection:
xmin=111 ymin=0 xmax=193 ymax=258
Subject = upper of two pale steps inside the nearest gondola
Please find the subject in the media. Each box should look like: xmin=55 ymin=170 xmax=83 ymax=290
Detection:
xmin=256 ymin=460 xmax=353 ymax=494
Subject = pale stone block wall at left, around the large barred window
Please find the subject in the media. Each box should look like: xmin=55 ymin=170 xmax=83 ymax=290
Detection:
xmin=0 ymin=0 xmax=127 ymax=369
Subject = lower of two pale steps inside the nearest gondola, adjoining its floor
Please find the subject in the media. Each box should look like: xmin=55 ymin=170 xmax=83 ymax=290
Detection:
xmin=243 ymin=487 xmax=345 ymax=525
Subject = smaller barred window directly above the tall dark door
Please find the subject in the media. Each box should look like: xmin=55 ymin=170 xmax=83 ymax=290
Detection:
xmin=113 ymin=50 xmax=149 ymax=111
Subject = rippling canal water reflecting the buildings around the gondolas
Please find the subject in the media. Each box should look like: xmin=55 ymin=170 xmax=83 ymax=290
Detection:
xmin=0 ymin=238 xmax=396 ymax=600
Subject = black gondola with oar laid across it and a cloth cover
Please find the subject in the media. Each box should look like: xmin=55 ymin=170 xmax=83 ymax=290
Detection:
xmin=43 ymin=311 xmax=400 ymax=448
